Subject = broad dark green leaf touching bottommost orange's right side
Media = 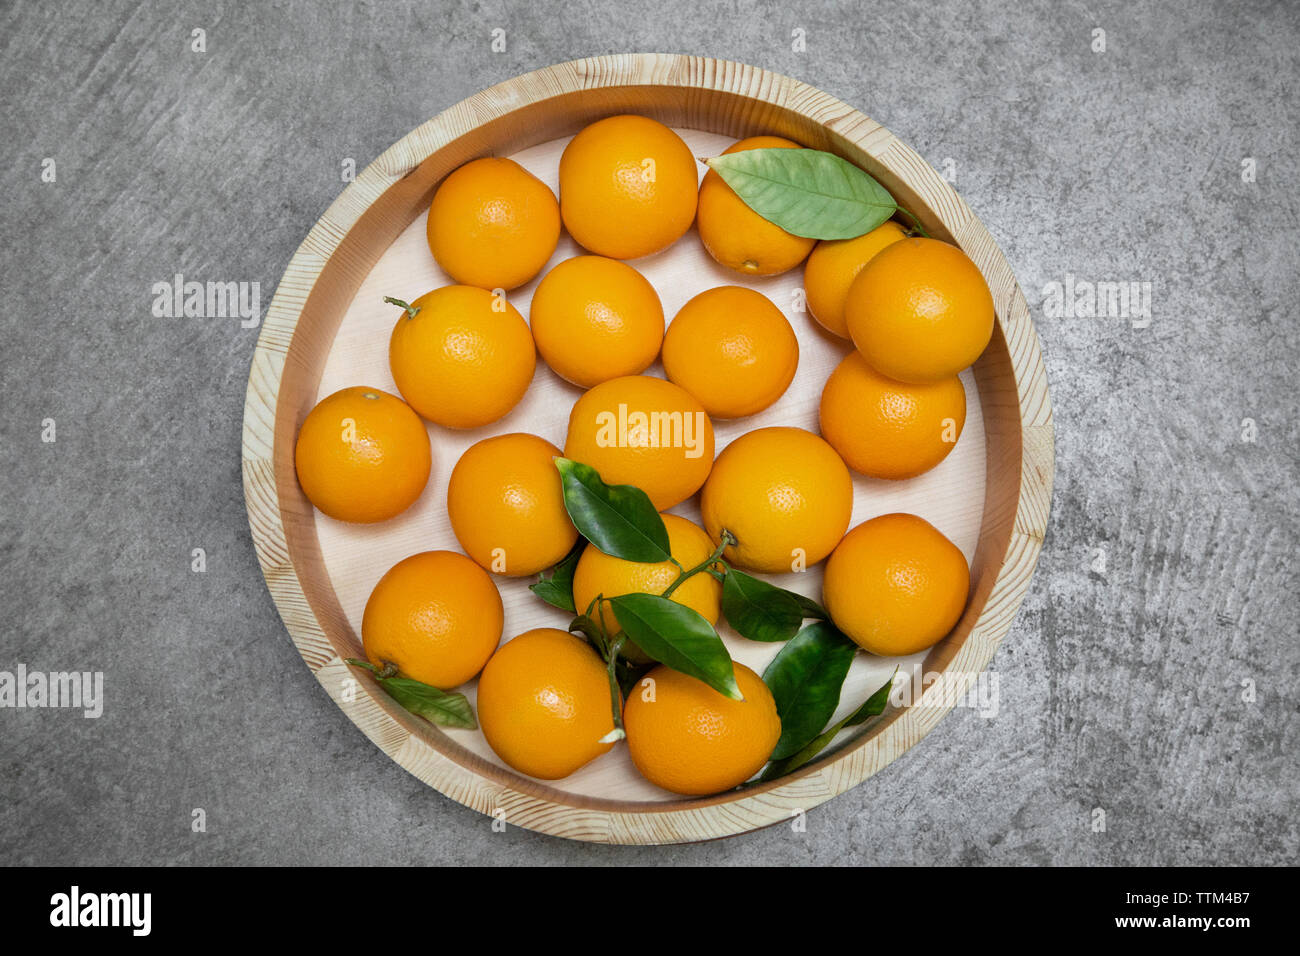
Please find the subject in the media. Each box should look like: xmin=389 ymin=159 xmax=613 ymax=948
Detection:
xmin=763 ymin=620 xmax=858 ymax=760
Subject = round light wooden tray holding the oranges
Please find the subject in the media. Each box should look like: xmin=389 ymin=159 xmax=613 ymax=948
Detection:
xmin=243 ymin=55 xmax=1053 ymax=844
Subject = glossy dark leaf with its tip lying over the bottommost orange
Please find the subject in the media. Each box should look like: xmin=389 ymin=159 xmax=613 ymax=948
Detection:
xmin=608 ymin=593 xmax=744 ymax=700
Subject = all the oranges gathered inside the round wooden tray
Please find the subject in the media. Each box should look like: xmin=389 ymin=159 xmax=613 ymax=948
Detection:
xmin=295 ymin=116 xmax=993 ymax=795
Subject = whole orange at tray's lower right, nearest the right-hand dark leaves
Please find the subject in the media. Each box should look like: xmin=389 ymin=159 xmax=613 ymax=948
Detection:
xmin=822 ymin=514 xmax=970 ymax=656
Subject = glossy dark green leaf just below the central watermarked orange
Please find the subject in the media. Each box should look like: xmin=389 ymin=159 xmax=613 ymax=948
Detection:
xmin=555 ymin=458 xmax=672 ymax=563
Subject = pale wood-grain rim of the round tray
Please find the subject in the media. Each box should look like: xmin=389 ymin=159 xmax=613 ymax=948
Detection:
xmin=242 ymin=53 xmax=1054 ymax=844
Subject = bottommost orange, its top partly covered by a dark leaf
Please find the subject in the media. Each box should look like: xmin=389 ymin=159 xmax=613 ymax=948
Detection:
xmin=623 ymin=663 xmax=781 ymax=796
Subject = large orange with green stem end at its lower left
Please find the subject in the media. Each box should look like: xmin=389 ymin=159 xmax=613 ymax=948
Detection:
xmin=699 ymin=428 xmax=853 ymax=574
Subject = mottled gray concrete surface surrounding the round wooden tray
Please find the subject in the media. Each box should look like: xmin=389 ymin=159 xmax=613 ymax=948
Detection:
xmin=0 ymin=0 xmax=1300 ymax=864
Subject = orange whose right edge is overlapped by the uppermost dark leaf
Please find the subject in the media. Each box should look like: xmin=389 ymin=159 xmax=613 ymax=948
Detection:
xmin=447 ymin=433 xmax=577 ymax=578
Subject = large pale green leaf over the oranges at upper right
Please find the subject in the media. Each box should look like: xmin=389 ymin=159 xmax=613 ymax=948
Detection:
xmin=706 ymin=148 xmax=898 ymax=239
